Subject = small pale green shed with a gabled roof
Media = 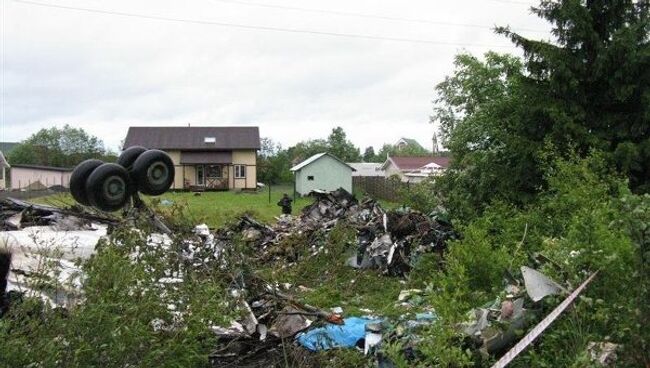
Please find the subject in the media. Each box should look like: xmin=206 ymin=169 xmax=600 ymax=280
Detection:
xmin=291 ymin=152 xmax=356 ymax=196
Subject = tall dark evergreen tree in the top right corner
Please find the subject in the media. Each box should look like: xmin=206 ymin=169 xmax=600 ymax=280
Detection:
xmin=498 ymin=0 xmax=650 ymax=192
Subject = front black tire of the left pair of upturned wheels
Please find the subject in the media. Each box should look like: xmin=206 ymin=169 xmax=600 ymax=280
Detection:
xmin=86 ymin=164 xmax=134 ymax=212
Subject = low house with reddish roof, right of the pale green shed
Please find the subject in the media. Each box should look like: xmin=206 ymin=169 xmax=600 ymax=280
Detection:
xmin=381 ymin=156 xmax=450 ymax=183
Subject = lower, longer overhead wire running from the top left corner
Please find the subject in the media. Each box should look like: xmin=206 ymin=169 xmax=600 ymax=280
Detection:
xmin=12 ymin=0 xmax=515 ymax=49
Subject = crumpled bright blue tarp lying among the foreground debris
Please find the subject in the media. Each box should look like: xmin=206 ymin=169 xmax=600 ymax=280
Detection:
xmin=296 ymin=317 xmax=381 ymax=351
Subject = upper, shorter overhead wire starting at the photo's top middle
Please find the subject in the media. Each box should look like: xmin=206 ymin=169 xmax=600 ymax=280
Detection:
xmin=205 ymin=0 xmax=547 ymax=33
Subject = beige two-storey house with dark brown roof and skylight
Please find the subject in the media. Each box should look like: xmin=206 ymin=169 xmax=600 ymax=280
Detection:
xmin=124 ymin=127 xmax=260 ymax=190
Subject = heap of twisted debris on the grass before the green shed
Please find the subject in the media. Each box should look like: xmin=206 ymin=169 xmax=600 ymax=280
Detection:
xmin=216 ymin=189 xmax=458 ymax=276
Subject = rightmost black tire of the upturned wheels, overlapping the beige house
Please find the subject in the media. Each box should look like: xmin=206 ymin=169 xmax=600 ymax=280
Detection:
xmin=130 ymin=150 xmax=175 ymax=195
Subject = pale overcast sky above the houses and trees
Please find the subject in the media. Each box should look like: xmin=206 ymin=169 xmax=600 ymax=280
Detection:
xmin=0 ymin=0 xmax=549 ymax=150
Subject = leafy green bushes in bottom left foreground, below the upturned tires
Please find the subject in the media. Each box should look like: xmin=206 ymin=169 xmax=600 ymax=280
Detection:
xmin=0 ymin=223 xmax=232 ymax=367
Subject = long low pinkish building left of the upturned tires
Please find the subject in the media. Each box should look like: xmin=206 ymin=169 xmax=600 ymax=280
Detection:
xmin=10 ymin=165 xmax=72 ymax=190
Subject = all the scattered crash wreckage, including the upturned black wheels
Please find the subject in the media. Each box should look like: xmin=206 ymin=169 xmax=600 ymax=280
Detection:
xmin=0 ymin=147 xmax=617 ymax=368
